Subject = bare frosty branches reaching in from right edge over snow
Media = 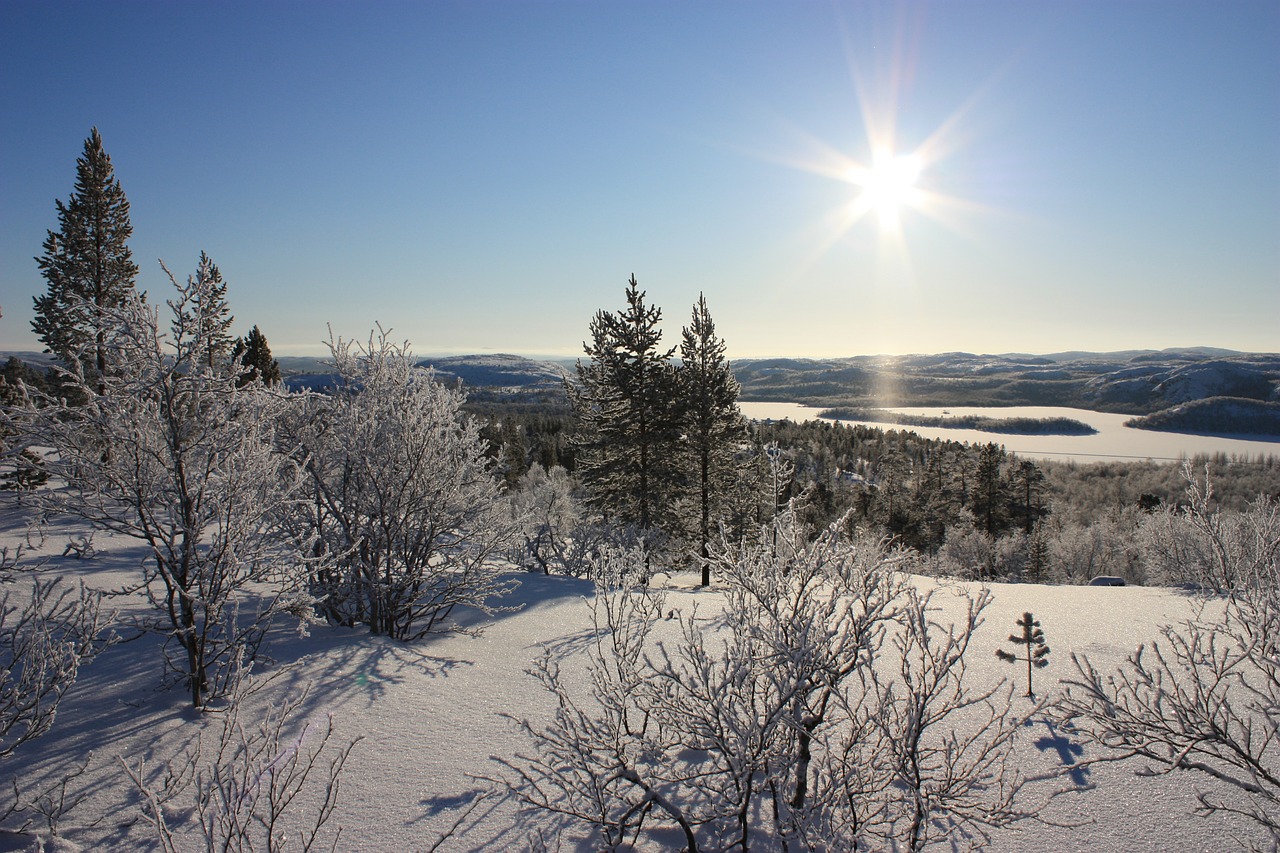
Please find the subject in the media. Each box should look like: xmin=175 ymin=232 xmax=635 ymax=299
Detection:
xmin=1061 ymin=482 xmax=1280 ymax=847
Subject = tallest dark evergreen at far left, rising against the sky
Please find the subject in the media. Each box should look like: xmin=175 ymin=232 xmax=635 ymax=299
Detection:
xmin=31 ymin=127 xmax=138 ymax=391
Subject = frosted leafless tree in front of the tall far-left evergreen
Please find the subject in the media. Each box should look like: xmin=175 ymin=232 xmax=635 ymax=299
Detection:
xmin=10 ymin=258 xmax=307 ymax=707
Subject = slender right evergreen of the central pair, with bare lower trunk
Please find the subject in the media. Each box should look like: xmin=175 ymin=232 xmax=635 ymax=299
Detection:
xmin=678 ymin=293 xmax=746 ymax=587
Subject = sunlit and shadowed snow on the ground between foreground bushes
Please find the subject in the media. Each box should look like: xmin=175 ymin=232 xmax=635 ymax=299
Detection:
xmin=0 ymin=494 xmax=1264 ymax=853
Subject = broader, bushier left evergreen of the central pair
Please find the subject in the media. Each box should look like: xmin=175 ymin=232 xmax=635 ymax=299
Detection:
xmin=568 ymin=275 xmax=681 ymax=545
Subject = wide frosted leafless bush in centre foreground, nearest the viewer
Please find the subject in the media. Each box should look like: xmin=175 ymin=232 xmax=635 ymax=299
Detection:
xmin=498 ymin=512 xmax=1021 ymax=852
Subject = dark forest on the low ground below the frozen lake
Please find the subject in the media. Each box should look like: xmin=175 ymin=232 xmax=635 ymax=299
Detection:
xmin=466 ymin=391 xmax=1280 ymax=583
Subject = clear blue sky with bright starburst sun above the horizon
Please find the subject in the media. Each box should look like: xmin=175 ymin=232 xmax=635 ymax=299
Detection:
xmin=0 ymin=0 xmax=1280 ymax=356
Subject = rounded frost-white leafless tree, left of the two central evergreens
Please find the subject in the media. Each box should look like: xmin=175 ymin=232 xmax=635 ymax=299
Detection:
xmin=288 ymin=329 xmax=518 ymax=640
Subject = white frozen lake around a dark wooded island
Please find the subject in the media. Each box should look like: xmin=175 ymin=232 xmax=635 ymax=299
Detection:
xmin=739 ymin=402 xmax=1280 ymax=462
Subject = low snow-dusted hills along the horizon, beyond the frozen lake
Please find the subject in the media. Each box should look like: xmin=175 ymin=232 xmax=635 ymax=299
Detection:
xmin=0 ymin=347 xmax=1280 ymax=434
